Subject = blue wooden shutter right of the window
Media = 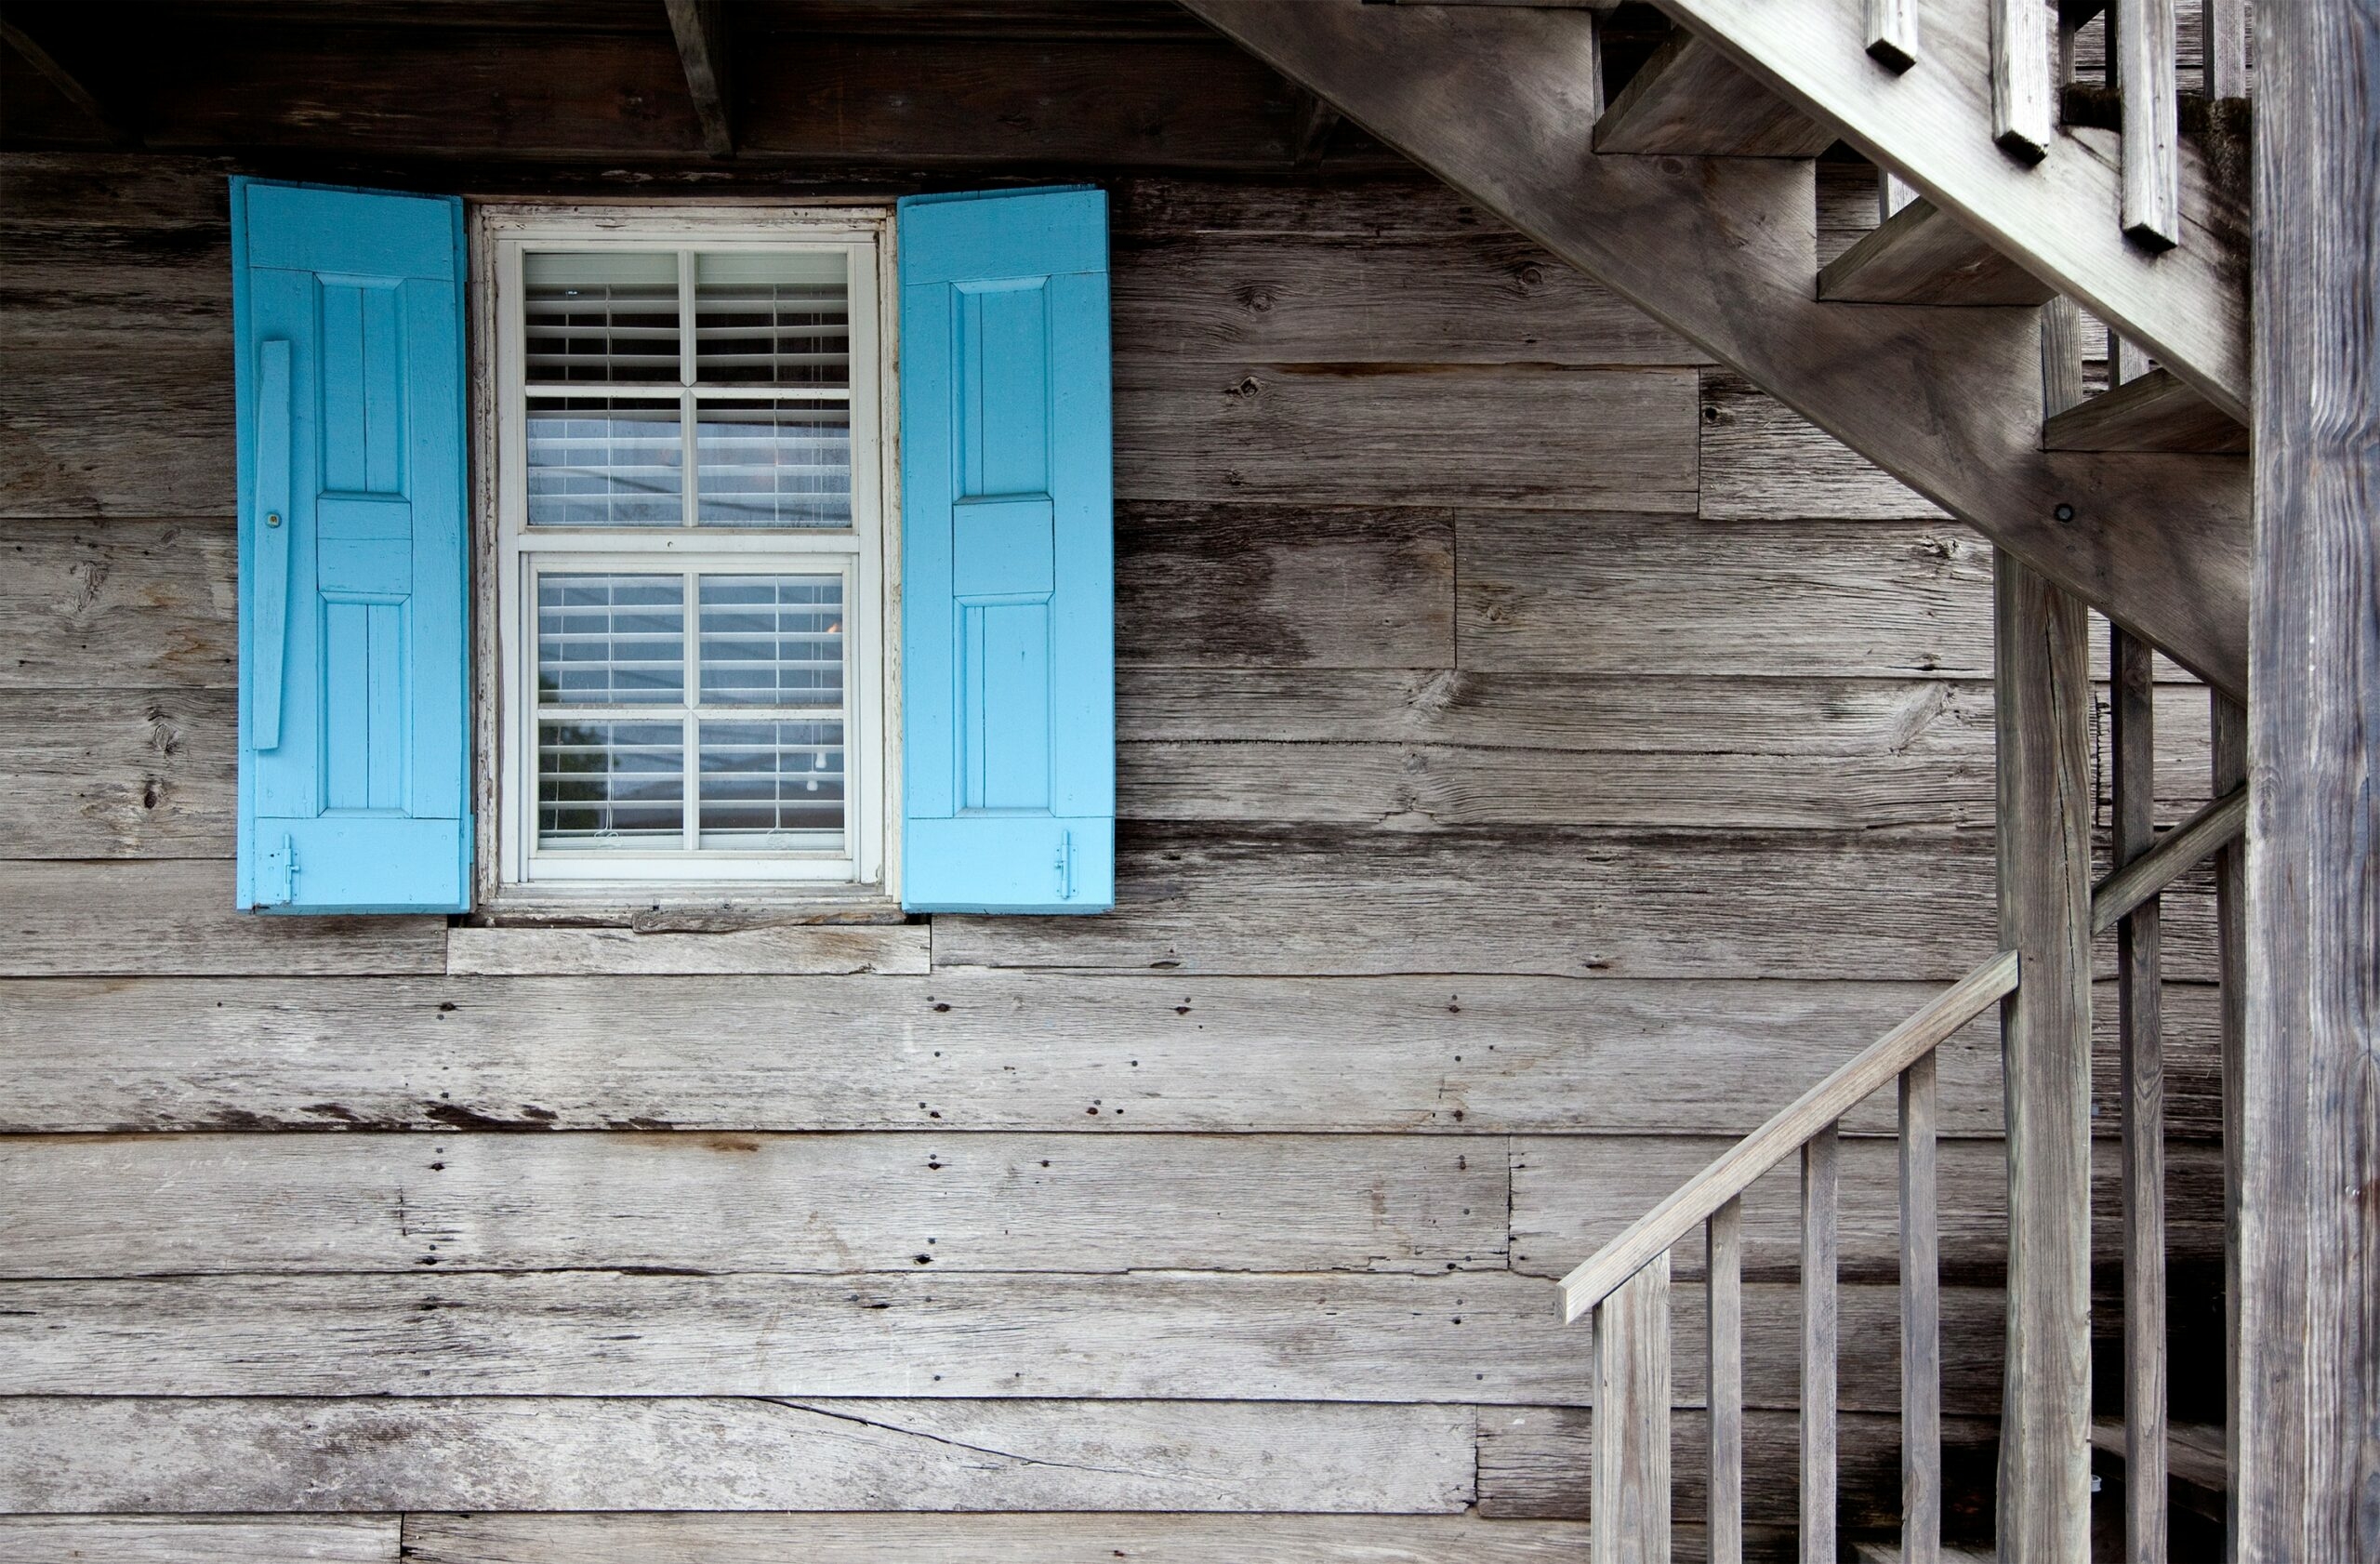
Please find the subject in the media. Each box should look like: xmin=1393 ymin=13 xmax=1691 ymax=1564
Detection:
xmin=900 ymin=188 xmax=1117 ymax=912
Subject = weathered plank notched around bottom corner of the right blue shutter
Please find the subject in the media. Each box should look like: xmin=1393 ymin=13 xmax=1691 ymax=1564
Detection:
xmin=933 ymin=824 xmax=1992 ymax=981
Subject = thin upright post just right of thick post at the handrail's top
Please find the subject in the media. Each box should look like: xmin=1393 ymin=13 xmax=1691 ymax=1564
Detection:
xmin=2109 ymin=629 xmax=2166 ymax=1564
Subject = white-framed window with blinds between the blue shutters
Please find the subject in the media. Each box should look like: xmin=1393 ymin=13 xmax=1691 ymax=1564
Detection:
xmin=485 ymin=209 xmax=895 ymax=900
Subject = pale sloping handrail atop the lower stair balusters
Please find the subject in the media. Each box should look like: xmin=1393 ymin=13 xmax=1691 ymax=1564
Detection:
xmin=1561 ymin=949 xmax=2016 ymax=1321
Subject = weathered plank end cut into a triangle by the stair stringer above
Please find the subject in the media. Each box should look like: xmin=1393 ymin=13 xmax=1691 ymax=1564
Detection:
xmin=1699 ymin=369 xmax=1945 ymax=522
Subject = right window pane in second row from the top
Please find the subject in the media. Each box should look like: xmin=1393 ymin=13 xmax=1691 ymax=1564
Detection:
xmin=695 ymin=403 xmax=852 ymax=526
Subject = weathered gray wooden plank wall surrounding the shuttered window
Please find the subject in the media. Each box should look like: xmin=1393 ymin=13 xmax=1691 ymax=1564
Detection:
xmin=0 ymin=149 xmax=2220 ymax=1564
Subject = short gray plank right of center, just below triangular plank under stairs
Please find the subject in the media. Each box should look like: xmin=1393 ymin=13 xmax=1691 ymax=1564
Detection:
xmin=1457 ymin=511 xmax=1992 ymax=679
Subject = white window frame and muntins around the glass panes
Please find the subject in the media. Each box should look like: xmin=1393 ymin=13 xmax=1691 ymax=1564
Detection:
xmin=488 ymin=212 xmax=897 ymax=895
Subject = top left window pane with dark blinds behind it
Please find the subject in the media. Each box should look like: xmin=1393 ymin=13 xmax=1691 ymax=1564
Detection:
xmin=522 ymin=252 xmax=679 ymax=386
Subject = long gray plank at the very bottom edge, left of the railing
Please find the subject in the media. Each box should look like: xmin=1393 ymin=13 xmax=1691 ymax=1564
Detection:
xmin=404 ymin=1514 xmax=1588 ymax=1564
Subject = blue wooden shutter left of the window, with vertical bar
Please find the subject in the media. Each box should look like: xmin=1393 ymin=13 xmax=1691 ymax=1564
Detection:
xmin=231 ymin=179 xmax=471 ymax=912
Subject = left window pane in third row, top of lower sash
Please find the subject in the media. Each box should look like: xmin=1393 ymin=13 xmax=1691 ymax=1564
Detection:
xmin=538 ymin=574 xmax=685 ymax=707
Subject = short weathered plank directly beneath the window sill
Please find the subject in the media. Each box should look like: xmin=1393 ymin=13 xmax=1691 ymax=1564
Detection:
xmin=447 ymin=923 xmax=933 ymax=976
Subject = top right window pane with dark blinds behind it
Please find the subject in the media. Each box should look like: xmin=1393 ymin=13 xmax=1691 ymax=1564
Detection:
xmin=695 ymin=250 xmax=852 ymax=388
